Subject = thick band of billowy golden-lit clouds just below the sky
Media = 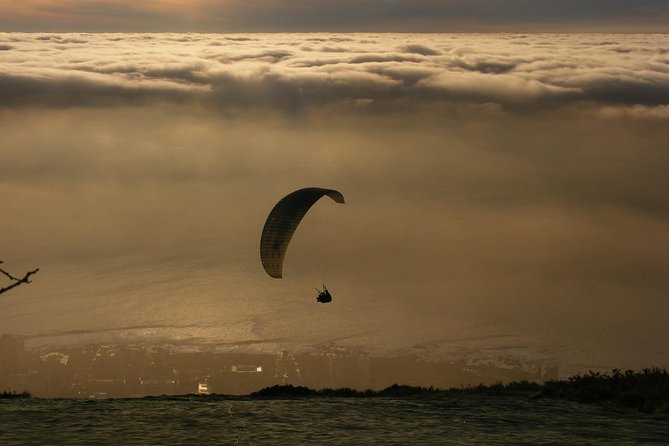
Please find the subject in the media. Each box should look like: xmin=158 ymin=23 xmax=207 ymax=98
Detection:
xmin=0 ymin=34 xmax=669 ymax=115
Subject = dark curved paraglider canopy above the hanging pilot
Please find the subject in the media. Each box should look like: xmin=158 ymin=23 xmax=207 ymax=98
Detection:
xmin=260 ymin=187 xmax=344 ymax=279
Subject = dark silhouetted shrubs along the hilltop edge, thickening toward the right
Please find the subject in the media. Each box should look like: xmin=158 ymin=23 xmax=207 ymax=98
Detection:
xmin=249 ymin=368 xmax=669 ymax=414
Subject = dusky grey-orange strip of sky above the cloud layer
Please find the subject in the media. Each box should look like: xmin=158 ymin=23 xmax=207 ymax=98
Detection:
xmin=0 ymin=0 xmax=669 ymax=33
